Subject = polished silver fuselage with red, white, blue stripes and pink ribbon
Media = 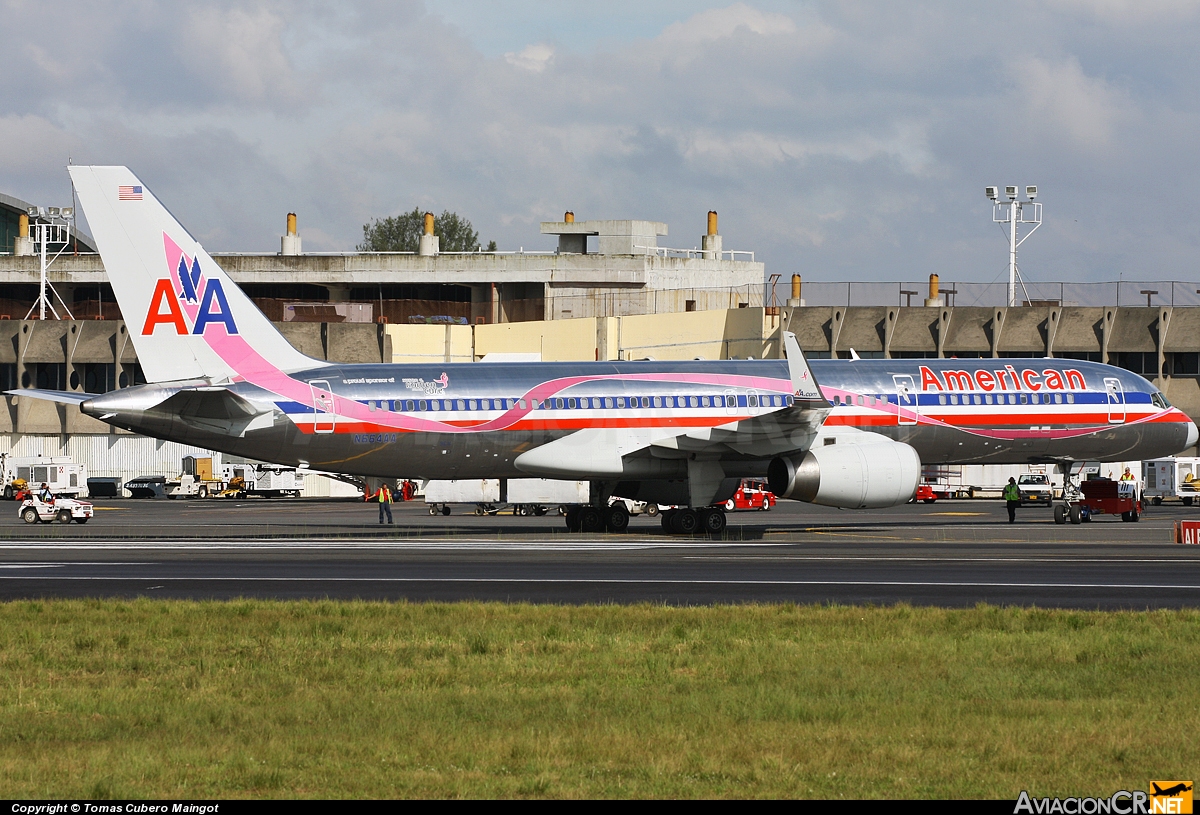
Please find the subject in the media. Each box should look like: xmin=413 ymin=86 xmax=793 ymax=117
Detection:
xmin=82 ymin=359 xmax=1195 ymax=479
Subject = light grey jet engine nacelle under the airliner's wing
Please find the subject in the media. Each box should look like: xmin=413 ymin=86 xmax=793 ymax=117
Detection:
xmin=767 ymin=442 xmax=920 ymax=509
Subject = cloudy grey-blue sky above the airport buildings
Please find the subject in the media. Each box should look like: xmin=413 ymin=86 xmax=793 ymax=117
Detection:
xmin=0 ymin=0 xmax=1200 ymax=292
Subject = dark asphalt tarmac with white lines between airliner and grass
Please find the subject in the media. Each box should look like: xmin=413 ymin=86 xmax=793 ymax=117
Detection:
xmin=0 ymin=501 xmax=1200 ymax=609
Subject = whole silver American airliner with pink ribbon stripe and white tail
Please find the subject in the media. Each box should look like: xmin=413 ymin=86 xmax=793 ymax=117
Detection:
xmin=11 ymin=166 xmax=1196 ymax=532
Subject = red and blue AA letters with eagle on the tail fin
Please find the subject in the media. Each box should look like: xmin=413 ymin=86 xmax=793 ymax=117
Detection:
xmin=142 ymin=234 xmax=238 ymax=336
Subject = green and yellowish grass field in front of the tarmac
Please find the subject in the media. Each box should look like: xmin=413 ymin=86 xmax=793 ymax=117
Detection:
xmin=0 ymin=600 xmax=1200 ymax=798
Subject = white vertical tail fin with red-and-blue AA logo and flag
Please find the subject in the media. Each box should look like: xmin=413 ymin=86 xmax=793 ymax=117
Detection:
xmin=70 ymin=166 xmax=325 ymax=382
